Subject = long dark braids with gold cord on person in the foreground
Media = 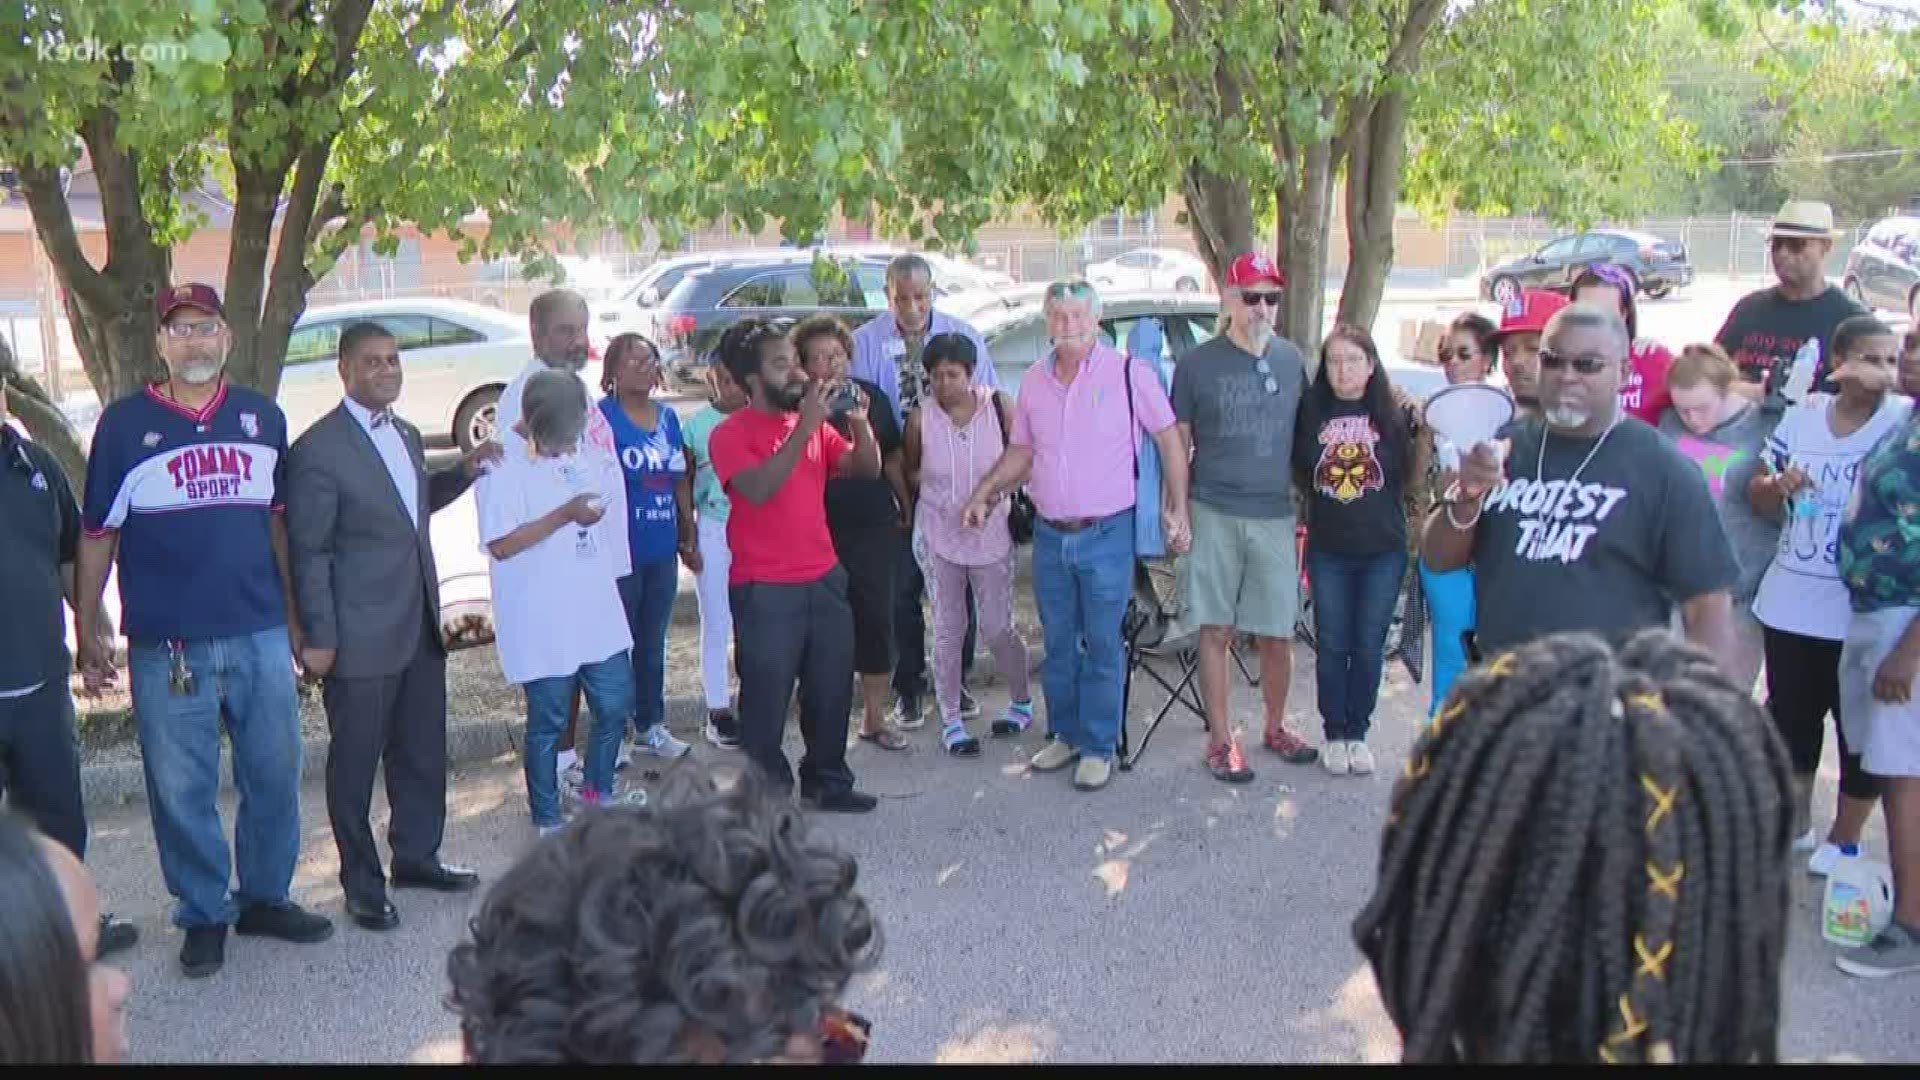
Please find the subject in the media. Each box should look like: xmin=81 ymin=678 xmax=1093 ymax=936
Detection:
xmin=1354 ymin=630 xmax=1793 ymax=1063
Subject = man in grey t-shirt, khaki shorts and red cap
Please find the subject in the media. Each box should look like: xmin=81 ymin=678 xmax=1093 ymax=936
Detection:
xmin=1173 ymin=254 xmax=1319 ymax=784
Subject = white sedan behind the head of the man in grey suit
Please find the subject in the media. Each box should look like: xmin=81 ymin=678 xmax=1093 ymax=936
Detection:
xmin=280 ymin=298 xmax=534 ymax=452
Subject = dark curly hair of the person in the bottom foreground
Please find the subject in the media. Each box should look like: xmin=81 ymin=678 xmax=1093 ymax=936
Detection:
xmin=447 ymin=765 xmax=881 ymax=1065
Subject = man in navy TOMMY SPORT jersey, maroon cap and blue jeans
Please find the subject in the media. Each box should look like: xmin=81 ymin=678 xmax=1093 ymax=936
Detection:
xmin=77 ymin=284 xmax=334 ymax=978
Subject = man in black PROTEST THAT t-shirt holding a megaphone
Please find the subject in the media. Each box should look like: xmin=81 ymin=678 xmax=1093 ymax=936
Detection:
xmin=1423 ymin=304 xmax=1740 ymax=671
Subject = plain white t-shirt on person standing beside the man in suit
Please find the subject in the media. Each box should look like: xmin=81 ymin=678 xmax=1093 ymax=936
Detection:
xmin=474 ymin=444 xmax=634 ymax=682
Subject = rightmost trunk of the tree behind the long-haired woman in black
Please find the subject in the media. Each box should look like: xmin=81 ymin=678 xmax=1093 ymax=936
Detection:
xmin=1338 ymin=90 xmax=1407 ymax=327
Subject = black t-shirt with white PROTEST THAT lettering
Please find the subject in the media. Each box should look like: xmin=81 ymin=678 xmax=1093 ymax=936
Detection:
xmin=1457 ymin=417 xmax=1740 ymax=655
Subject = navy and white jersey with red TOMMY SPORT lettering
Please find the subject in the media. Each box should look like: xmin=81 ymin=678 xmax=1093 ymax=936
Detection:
xmin=83 ymin=382 xmax=286 ymax=642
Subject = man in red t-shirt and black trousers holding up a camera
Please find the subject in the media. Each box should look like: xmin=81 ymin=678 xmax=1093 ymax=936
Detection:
xmin=707 ymin=319 xmax=879 ymax=813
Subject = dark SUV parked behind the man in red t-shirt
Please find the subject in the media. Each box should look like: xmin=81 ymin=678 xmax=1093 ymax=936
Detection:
xmin=655 ymin=252 xmax=887 ymax=386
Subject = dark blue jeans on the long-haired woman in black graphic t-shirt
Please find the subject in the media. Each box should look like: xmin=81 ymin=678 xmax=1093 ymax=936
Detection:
xmin=1308 ymin=540 xmax=1407 ymax=742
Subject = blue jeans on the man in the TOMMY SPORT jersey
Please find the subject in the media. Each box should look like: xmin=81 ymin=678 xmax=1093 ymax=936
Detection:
xmin=127 ymin=626 xmax=301 ymax=928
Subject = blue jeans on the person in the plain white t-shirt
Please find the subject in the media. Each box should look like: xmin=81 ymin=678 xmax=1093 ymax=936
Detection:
xmin=522 ymin=650 xmax=634 ymax=828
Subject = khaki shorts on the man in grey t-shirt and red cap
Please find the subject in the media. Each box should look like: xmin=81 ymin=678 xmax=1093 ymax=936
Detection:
xmin=1181 ymin=502 xmax=1300 ymax=638
